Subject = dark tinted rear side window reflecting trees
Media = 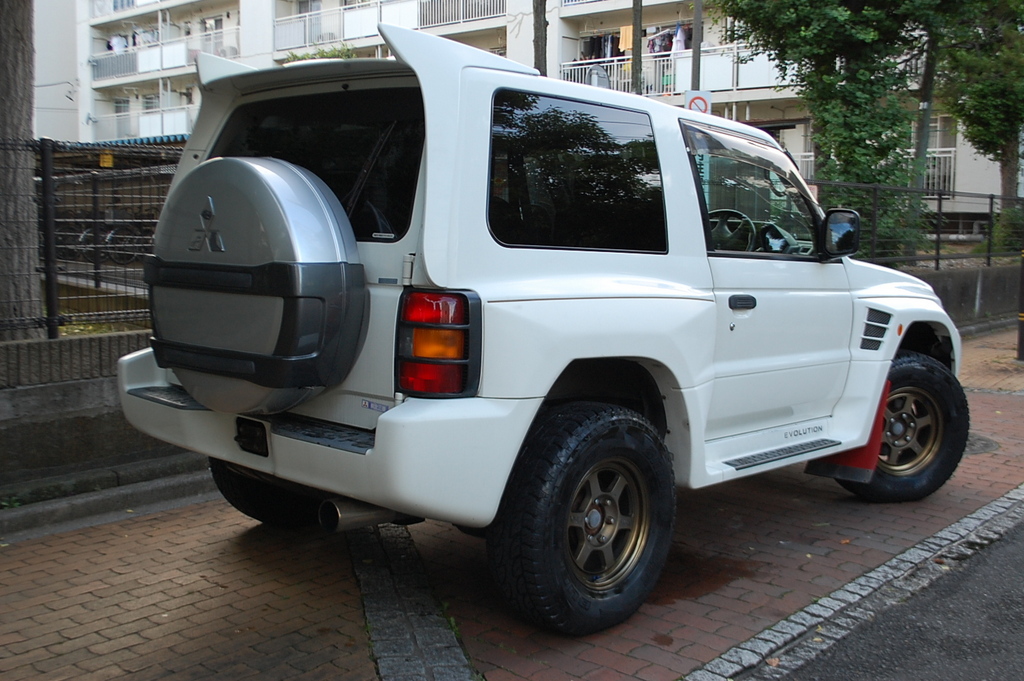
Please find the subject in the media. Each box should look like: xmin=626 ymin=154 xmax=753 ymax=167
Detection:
xmin=487 ymin=90 xmax=668 ymax=253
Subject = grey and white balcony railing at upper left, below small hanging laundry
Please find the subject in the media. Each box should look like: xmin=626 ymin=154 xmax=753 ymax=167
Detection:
xmin=90 ymin=28 xmax=239 ymax=81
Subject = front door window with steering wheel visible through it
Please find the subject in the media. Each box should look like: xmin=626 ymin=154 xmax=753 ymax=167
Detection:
xmin=683 ymin=124 xmax=814 ymax=255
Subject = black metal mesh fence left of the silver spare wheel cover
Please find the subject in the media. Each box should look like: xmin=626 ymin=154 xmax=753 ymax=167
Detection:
xmin=0 ymin=139 xmax=181 ymax=339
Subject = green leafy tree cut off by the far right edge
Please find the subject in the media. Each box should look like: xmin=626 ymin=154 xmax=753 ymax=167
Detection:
xmin=939 ymin=0 xmax=1024 ymax=249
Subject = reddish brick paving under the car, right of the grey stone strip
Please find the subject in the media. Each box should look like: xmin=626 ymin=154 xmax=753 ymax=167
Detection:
xmin=411 ymin=330 xmax=1024 ymax=681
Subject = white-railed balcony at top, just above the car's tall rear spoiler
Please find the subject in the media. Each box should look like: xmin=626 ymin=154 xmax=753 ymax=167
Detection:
xmin=273 ymin=0 xmax=505 ymax=51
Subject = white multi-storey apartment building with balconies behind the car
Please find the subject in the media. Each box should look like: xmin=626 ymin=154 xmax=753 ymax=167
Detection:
xmin=36 ymin=0 xmax=998 ymax=201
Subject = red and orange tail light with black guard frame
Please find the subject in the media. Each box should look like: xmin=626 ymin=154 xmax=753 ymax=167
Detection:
xmin=395 ymin=290 xmax=480 ymax=397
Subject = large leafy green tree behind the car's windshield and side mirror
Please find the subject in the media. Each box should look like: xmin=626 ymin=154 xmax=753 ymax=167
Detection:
xmin=716 ymin=0 xmax=974 ymax=255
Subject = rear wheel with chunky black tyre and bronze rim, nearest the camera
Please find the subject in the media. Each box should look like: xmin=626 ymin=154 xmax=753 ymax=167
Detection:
xmin=487 ymin=402 xmax=676 ymax=635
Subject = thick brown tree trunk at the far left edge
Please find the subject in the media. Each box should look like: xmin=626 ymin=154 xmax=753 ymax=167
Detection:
xmin=0 ymin=0 xmax=43 ymax=340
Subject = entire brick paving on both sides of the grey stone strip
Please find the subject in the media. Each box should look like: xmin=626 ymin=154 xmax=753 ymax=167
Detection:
xmin=0 ymin=332 xmax=1024 ymax=681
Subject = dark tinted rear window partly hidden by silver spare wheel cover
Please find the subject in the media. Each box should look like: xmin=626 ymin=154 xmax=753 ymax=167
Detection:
xmin=214 ymin=88 xmax=424 ymax=242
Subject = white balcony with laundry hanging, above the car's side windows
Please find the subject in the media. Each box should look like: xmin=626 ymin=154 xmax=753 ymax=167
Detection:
xmin=562 ymin=45 xmax=784 ymax=96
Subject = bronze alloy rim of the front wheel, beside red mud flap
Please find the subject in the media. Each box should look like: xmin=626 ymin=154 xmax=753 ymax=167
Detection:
xmin=879 ymin=386 xmax=943 ymax=475
